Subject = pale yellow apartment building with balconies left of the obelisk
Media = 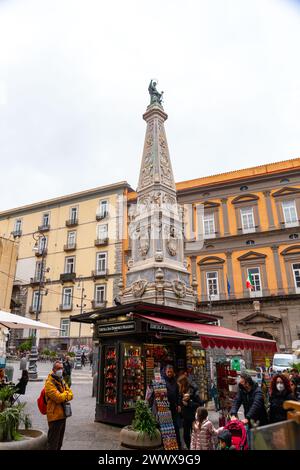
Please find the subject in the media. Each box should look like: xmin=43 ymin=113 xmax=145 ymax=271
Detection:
xmin=0 ymin=182 xmax=131 ymax=350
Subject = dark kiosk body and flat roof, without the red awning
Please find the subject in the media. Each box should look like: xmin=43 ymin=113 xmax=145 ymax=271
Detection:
xmin=72 ymin=302 xmax=219 ymax=426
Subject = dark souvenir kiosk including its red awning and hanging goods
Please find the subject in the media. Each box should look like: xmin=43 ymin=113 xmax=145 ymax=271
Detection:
xmin=70 ymin=301 xmax=276 ymax=425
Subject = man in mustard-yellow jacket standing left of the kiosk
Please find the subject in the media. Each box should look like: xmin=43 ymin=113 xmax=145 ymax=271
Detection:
xmin=45 ymin=361 xmax=73 ymax=450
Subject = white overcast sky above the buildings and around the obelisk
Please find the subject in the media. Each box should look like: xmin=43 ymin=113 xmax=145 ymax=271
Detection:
xmin=0 ymin=0 xmax=300 ymax=210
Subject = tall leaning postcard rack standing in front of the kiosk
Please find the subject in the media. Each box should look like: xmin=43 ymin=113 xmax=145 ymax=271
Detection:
xmin=152 ymin=379 xmax=178 ymax=450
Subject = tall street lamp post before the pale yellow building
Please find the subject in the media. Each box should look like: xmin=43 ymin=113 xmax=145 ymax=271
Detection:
xmin=28 ymin=232 xmax=49 ymax=381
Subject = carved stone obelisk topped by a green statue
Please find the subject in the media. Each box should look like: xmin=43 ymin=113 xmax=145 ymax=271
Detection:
xmin=120 ymin=80 xmax=197 ymax=310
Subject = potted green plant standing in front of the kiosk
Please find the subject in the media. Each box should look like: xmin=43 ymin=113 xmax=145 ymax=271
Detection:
xmin=120 ymin=400 xmax=161 ymax=449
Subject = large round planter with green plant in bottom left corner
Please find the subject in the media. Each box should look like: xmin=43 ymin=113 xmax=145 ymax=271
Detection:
xmin=0 ymin=385 xmax=47 ymax=451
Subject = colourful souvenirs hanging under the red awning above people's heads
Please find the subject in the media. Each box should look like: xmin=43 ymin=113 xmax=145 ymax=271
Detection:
xmin=186 ymin=343 xmax=208 ymax=401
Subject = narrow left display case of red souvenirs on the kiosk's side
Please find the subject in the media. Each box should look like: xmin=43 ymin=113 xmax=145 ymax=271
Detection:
xmin=103 ymin=346 xmax=117 ymax=405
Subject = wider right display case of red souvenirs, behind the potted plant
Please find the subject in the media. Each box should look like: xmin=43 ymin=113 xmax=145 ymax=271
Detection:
xmin=122 ymin=344 xmax=145 ymax=410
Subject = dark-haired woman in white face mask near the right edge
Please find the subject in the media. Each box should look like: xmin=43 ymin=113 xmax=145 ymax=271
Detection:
xmin=269 ymin=374 xmax=293 ymax=423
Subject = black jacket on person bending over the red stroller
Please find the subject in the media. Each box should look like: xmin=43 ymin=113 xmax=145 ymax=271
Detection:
xmin=230 ymin=383 xmax=268 ymax=426
